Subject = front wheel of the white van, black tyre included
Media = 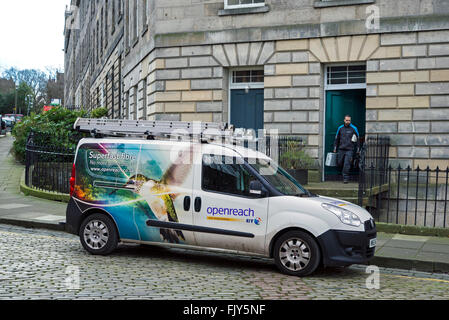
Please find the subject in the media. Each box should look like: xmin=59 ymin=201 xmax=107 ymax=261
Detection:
xmin=273 ymin=230 xmax=321 ymax=277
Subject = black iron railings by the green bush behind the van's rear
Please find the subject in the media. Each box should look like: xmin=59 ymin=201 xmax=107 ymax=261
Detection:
xmin=25 ymin=132 xmax=75 ymax=194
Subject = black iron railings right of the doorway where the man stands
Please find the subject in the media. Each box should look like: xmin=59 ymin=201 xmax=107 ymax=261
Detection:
xmin=359 ymin=136 xmax=449 ymax=228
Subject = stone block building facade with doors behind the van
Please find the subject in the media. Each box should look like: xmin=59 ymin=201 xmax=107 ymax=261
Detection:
xmin=66 ymin=0 xmax=449 ymax=178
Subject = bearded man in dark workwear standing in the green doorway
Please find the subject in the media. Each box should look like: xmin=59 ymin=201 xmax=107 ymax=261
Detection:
xmin=334 ymin=115 xmax=360 ymax=183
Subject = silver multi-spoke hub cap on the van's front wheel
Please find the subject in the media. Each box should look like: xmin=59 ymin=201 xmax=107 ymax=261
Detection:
xmin=279 ymin=238 xmax=311 ymax=271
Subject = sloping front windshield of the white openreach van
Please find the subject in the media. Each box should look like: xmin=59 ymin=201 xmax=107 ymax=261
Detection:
xmin=247 ymin=159 xmax=312 ymax=197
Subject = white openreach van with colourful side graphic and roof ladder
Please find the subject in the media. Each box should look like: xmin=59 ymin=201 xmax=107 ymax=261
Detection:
xmin=66 ymin=119 xmax=376 ymax=276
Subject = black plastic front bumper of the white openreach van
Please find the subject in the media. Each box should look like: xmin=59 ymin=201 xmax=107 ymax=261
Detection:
xmin=318 ymin=227 xmax=377 ymax=267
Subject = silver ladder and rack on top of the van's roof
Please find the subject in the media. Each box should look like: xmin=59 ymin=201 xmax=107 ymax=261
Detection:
xmin=73 ymin=118 xmax=256 ymax=140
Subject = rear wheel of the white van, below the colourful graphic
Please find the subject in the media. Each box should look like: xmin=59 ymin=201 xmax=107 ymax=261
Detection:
xmin=79 ymin=213 xmax=118 ymax=255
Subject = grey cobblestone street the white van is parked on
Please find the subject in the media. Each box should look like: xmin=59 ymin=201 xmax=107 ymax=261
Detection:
xmin=0 ymin=225 xmax=449 ymax=300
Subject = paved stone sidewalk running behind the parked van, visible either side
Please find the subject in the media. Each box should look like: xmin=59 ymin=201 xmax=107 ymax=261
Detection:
xmin=0 ymin=134 xmax=449 ymax=273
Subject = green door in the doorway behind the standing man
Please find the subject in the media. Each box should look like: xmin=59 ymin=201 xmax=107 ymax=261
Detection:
xmin=324 ymin=89 xmax=366 ymax=180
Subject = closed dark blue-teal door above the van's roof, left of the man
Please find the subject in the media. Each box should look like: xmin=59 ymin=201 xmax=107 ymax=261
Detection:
xmin=231 ymin=89 xmax=264 ymax=133
